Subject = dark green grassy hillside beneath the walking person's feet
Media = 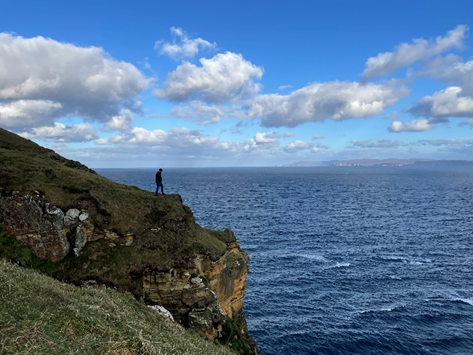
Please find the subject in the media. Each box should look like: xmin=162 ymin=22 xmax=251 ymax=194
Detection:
xmin=0 ymin=129 xmax=226 ymax=289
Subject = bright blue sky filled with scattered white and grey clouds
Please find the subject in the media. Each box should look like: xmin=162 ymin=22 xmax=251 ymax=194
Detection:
xmin=0 ymin=0 xmax=473 ymax=168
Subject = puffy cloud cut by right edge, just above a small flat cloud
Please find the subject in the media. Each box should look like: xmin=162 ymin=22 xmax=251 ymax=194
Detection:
xmin=407 ymin=86 xmax=473 ymax=122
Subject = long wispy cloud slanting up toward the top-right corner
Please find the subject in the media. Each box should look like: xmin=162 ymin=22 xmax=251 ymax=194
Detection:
xmin=361 ymin=25 xmax=468 ymax=81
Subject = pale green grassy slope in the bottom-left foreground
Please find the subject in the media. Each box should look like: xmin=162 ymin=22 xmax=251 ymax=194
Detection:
xmin=0 ymin=260 xmax=235 ymax=355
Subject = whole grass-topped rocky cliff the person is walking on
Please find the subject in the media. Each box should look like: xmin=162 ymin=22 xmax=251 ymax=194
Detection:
xmin=0 ymin=129 xmax=256 ymax=354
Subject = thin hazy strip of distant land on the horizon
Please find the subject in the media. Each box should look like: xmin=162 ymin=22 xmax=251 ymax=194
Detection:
xmin=277 ymin=159 xmax=473 ymax=168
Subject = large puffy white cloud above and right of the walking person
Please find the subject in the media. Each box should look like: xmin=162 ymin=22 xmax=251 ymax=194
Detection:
xmin=154 ymin=52 xmax=263 ymax=104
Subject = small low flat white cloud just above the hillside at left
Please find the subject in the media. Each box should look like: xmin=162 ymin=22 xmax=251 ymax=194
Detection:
xmin=20 ymin=122 xmax=98 ymax=143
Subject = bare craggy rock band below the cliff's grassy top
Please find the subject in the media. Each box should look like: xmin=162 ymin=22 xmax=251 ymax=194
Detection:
xmin=0 ymin=189 xmax=257 ymax=354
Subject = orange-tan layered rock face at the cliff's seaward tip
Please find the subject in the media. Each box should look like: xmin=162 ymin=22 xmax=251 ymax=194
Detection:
xmin=143 ymin=230 xmax=249 ymax=338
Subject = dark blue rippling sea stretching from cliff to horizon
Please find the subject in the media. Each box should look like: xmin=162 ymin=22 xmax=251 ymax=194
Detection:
xmin=98 ymin=168 xmax=473 ymax=355
